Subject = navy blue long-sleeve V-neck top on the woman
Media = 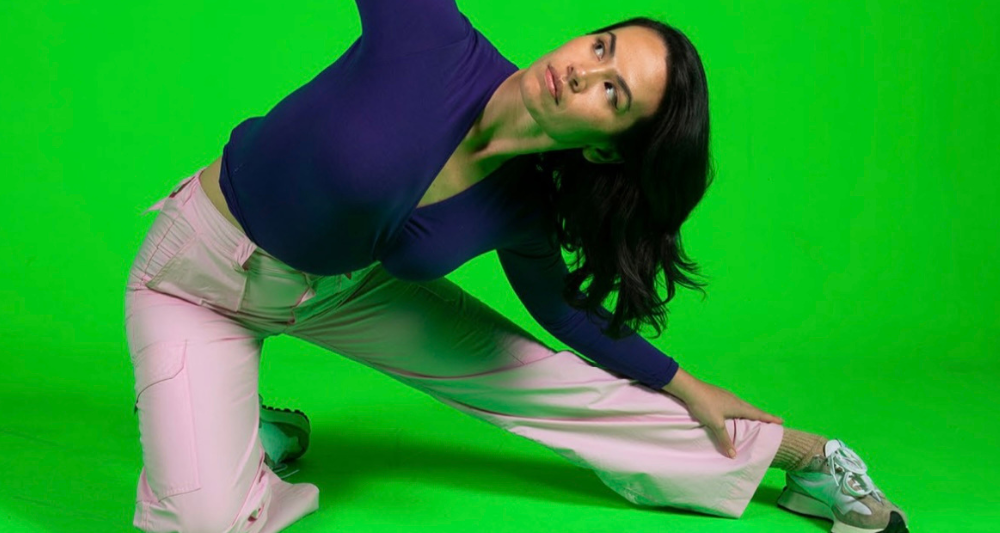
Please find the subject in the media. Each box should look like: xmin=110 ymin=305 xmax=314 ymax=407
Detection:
xmin=220 ymin=0 xmax=678 ymax=389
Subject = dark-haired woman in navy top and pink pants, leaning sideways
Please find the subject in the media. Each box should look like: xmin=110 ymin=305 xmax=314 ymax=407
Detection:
xmin=126 ymin=0 xmax=906 ymax=533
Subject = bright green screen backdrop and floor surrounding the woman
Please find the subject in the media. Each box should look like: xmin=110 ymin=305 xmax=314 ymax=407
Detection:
xmin=0 ymin=0 xmax=1000 ymax=533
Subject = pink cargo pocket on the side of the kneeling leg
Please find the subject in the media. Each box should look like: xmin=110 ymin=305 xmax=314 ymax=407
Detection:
xmin=135 ymin=342 xmax=201 ymax=500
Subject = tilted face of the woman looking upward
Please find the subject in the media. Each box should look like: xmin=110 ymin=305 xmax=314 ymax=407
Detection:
xmin=520 ymin=26 xmax=667 ymax=162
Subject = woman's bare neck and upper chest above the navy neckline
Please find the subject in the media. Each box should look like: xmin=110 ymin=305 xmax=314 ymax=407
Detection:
xmin=463 ymin=69 xmax=570 ymax=167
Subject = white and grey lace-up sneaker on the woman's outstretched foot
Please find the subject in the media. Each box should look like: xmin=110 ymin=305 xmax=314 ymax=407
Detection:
xmin=778 ymin=440 xmax=909 ymax=533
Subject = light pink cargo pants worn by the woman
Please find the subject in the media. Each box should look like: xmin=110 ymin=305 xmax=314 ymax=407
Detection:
xmin=125 ymin=164 xmax=783 ymax=533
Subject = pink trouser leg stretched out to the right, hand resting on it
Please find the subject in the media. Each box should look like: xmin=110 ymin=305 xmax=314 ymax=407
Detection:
xmin=286 ymin=268 xmax=783 ymax=517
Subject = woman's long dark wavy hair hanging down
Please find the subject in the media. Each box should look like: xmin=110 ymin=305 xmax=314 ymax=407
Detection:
xmin=537 ymin=17 xmax=714 ymax=339
